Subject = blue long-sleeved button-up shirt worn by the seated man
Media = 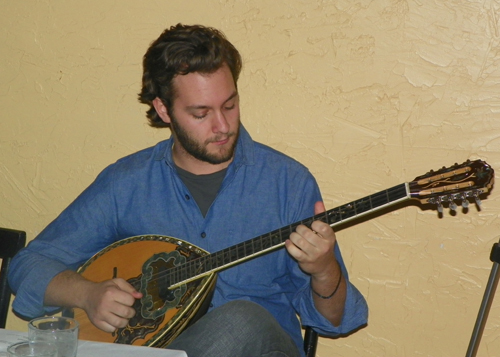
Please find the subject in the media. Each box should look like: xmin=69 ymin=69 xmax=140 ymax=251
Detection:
xmin=9 ymin=127 xmax=367 ymax=351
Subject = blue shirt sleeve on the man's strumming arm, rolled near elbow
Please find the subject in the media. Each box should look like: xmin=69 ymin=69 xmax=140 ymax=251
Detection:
xmin=8 ymin=166 xmax=118 ymax=318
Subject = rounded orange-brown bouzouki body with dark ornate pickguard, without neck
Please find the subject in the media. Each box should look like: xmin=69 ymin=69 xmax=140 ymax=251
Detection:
xmin=64 ymin=235 xmax=216 ymax=347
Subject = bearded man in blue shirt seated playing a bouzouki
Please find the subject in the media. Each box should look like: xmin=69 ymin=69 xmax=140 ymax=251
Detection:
xmin=9 ymin=24 xmax=367 ymax=357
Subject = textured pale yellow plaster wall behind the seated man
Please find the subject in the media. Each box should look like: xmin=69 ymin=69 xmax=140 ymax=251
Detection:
xmin=0 ymin=0 xmax=500 ymax=357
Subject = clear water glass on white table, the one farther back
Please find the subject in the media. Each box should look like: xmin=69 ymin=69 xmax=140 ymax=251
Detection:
xmin=28 ymin=316 xmax=79 ymax=357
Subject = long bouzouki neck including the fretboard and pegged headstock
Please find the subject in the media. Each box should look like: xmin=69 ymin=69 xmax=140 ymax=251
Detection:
xmin=168 ymin=160 xmax=494 ymax=289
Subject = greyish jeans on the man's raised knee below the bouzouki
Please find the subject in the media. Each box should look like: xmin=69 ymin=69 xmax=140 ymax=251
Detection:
xmin=168 ymin=300 xmax=303 ymax=357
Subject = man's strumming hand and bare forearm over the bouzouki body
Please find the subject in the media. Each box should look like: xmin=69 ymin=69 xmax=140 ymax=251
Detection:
xmin=44 ymin=270 xmax=142 ymax=332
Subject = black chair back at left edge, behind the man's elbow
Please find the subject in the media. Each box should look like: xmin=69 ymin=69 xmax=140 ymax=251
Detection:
xmin=0 ymin=228 xmax=26 ymax=328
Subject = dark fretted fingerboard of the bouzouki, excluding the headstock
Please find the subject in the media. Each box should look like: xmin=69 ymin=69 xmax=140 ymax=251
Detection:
xmin=168 ymin=183 xmax=410 ymax=289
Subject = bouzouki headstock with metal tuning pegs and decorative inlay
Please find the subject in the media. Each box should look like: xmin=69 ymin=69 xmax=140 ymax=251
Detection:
xmin=409 ymin=160 xmax=495 ymax=212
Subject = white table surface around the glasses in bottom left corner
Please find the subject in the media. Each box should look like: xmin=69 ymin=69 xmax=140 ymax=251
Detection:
xmin=0 ymin=329 xmax=187 ymax=357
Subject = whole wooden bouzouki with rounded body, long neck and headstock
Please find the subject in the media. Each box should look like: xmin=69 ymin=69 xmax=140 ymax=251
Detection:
xmin=63 ymin=160 xmax=494 ymax=347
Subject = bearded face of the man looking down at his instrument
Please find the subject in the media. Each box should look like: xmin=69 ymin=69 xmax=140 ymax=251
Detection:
xmin=157 ymin=66 xmax=240 ymax=165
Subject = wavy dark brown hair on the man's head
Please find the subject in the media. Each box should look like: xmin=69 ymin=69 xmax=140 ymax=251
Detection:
xmin=139 ymin=24 xmax=242 ymax=127
